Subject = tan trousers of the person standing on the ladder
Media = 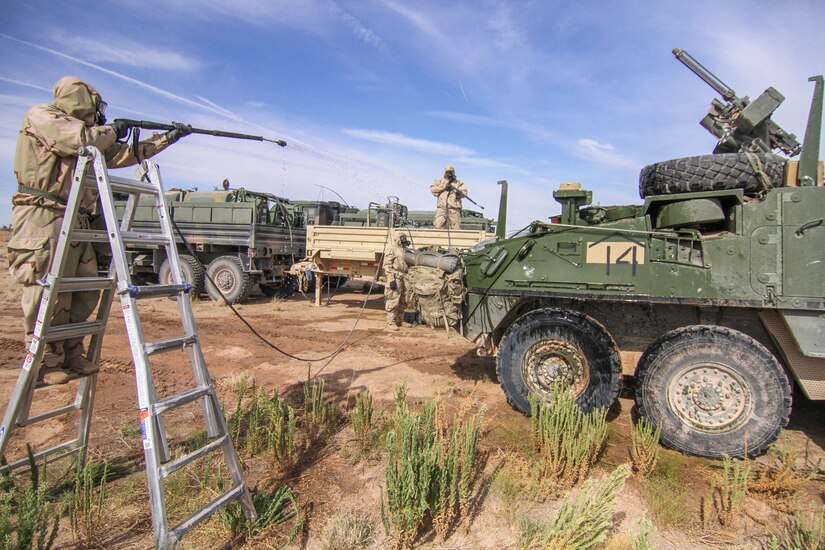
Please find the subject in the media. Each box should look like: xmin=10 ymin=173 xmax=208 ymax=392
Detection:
xmin=8 ymin=205 xmax=100 ymax=367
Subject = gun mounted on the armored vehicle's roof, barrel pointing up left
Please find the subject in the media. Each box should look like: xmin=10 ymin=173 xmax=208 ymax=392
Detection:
xmin=673 ymin=48 xmax=802 ymax=157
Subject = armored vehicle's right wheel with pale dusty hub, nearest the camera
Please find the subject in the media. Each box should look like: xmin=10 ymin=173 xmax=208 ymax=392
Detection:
xmin=636 ymin=325 xmax=791 ymax=458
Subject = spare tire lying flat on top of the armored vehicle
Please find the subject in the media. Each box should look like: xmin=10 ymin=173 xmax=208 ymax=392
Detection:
xmin=639 ymin=153 xmax=787 ymax=198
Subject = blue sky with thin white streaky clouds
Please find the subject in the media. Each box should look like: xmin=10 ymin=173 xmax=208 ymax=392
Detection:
xmin=0 ymin=0 xmax=825 ymax=229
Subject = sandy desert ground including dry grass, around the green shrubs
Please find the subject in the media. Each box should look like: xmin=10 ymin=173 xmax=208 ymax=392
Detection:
xmin=0 ymin=231 xmax=825 ymax=549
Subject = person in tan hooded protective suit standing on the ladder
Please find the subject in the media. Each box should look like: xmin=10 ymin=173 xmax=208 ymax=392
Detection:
xmin=8 ymin=76 xmax=191 ymax=384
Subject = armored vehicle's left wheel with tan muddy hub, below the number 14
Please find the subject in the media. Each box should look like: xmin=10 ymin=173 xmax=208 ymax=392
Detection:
xmin=496 ymin=309 xmax=621 ymax=414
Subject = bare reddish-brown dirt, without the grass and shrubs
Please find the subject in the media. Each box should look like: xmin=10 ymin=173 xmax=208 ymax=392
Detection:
xmin=0 ymin=231 xmax=825 ymax=549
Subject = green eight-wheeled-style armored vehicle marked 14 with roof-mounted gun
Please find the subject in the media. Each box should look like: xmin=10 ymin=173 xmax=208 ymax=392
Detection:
xmin=454 ymin=50 xmax=825 ymax=458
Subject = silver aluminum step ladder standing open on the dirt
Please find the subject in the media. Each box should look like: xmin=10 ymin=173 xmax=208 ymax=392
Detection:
xmin=0 ymin=147 xmax=256 ymax=548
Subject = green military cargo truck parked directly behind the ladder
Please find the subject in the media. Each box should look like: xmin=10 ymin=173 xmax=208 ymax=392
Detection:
xmin=105 ymin=188 xmax=306 ymax=303
